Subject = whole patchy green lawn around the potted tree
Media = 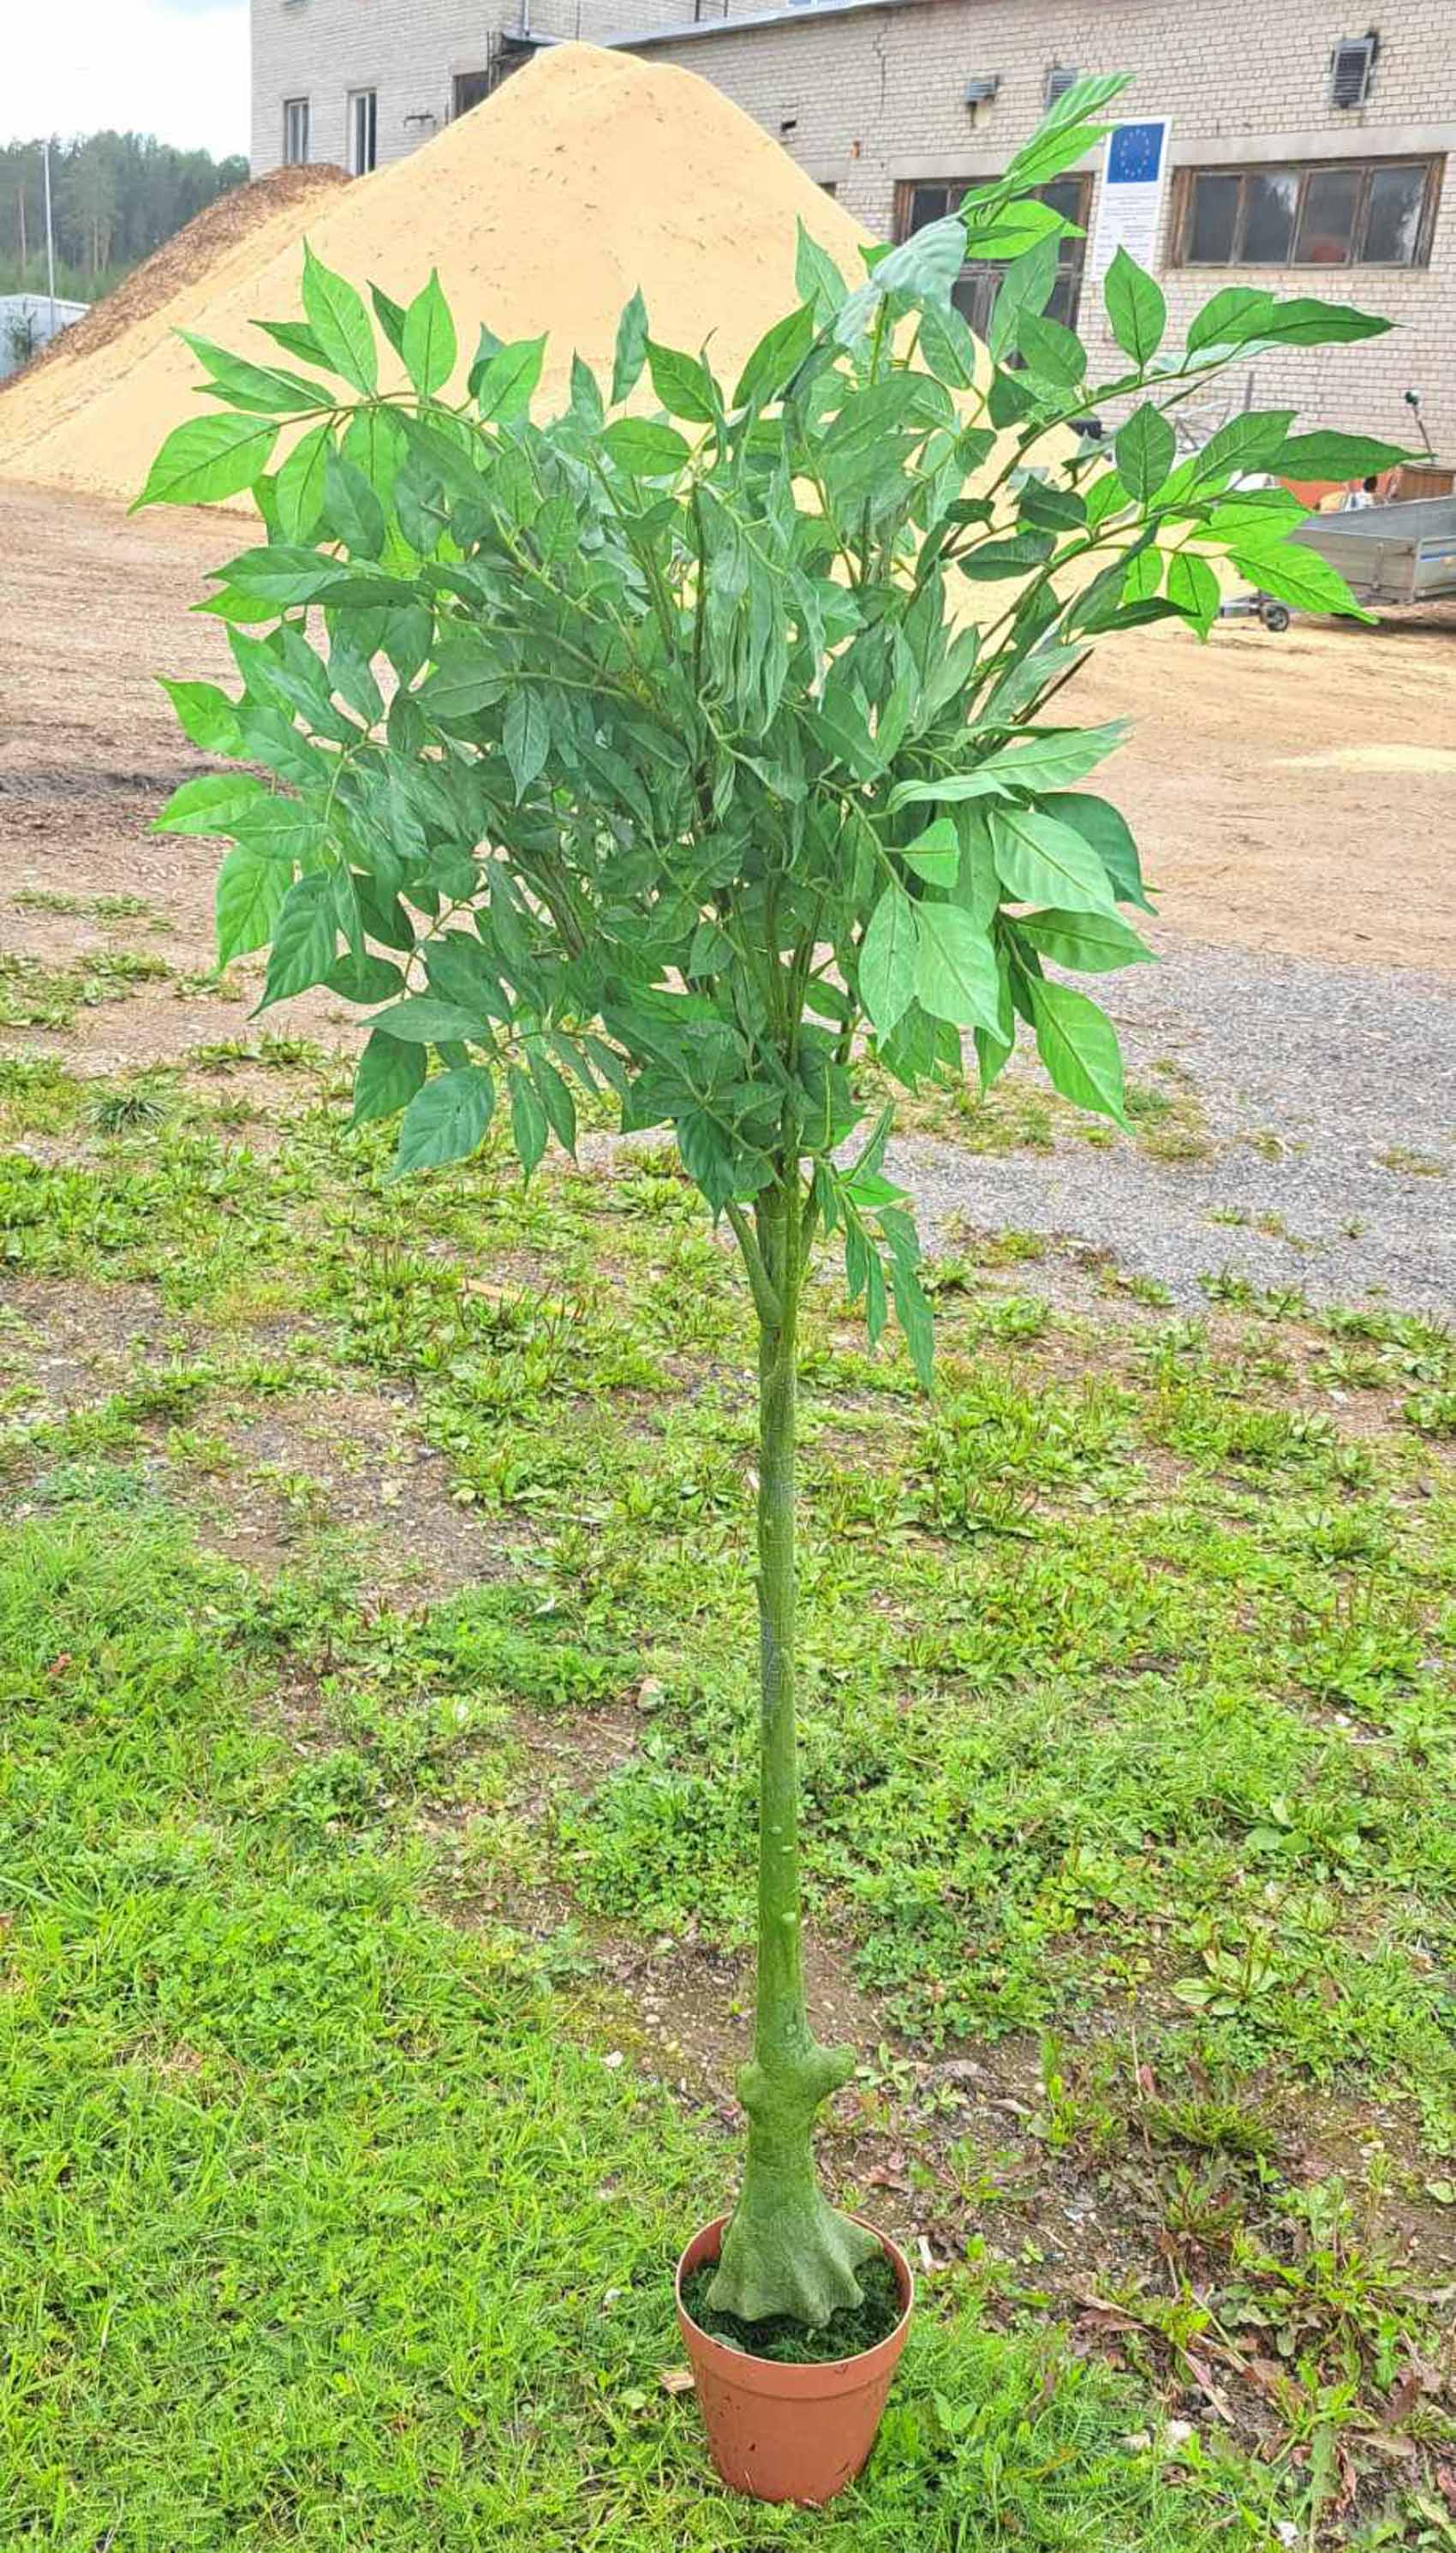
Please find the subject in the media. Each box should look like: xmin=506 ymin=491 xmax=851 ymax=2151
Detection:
xmin=0 ymin=1042 xmax=1456 ymax=2553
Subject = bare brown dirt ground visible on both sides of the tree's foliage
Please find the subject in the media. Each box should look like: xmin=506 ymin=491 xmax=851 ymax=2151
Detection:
xmin=0 ymin=487 xmax=1456 ymax=1011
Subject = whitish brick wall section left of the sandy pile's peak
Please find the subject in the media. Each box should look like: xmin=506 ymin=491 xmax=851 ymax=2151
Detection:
xmin=250 ymin=0 xmax=687 ymax=176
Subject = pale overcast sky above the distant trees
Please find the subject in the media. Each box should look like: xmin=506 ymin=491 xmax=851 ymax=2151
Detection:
xmin=0 ymin=0 xmax=248 ymax=158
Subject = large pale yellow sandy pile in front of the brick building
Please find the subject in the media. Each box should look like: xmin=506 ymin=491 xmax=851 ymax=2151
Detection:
xmin=0 ymin=44 xmax=866 ymax=498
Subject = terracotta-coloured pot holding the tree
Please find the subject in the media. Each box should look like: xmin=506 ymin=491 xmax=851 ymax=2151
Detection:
xmin=677 ymin=2216 xmax=915 ymax=2509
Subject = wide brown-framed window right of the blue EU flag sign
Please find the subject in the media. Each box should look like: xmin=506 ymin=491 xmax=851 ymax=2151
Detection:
xmin=1175 ymin=158 xmax=1441 ymax=266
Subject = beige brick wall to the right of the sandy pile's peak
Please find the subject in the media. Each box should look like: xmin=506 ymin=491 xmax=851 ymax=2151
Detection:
xmin=630 ymin=0 xmax=1456 ymax=446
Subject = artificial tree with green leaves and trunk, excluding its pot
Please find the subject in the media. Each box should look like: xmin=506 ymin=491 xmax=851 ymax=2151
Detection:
xmin=140 ymin=79 xmax=1392 ymax=2326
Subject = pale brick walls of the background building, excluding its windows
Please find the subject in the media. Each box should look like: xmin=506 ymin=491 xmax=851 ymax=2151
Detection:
xmin=253 ymin=0 xmax=1456 ymax=459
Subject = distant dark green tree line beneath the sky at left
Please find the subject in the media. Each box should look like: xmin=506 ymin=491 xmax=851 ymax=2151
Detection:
xmin=0 ymin=133 xmax=248 ymax=302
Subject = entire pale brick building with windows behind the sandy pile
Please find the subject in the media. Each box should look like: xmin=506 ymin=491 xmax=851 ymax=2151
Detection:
xmin=253 ymin=0 xmax=1456 ymax=446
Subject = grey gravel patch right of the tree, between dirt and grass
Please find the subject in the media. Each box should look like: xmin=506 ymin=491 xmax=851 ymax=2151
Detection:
xmin=889 ymin=942 xmax=1456 ymax=1315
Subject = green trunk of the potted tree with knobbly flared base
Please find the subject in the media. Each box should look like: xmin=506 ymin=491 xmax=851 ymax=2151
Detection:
xmin=710 ymin=1167 xmax=876 ymax=2323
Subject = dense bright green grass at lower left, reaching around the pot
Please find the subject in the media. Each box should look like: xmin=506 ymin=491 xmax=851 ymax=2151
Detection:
xmin=0 ymin=1511 xmax=1256 ymax=2553
